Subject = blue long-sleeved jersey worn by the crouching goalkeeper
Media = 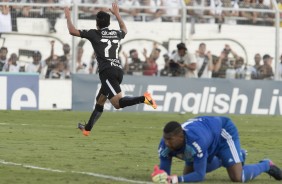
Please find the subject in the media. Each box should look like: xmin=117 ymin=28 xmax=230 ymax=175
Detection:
xmin=159 ymin=116 xmax=238 ymax=182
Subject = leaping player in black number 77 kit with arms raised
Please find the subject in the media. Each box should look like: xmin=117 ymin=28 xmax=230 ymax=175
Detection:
xmin=65 ymin=3 xmax=157 ymax=136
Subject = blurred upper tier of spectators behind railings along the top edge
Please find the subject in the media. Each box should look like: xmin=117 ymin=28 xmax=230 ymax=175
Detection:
xmin=0 ymin=0 xmax=282 ymax=33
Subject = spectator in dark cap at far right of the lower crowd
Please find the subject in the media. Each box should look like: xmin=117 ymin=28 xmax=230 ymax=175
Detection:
xmin=258 ymin=54 xmax=274 ymax=80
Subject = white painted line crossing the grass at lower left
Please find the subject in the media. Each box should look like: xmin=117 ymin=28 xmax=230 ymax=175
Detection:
xmin=0 ymin=160 xmax=151 ymax=184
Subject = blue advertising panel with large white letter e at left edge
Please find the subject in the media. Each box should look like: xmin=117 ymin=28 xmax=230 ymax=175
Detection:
xmin=0 ymin=72 xmax=39 ymax=110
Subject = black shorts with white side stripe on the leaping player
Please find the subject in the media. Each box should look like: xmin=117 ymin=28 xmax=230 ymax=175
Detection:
xmin=99 ymin=68 xmax=123 ymax=99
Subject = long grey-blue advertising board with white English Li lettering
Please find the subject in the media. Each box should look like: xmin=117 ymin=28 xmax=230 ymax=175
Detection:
xmin=72 ymin=74 xmax=282 ymax=115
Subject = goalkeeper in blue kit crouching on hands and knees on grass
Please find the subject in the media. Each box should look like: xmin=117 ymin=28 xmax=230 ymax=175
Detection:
xmin=152 ymin=116 xmax=282 ymax=183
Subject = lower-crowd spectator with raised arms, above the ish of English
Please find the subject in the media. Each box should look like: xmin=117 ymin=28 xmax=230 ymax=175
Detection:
xmin=213 ymin=44 xmax=239 ymax=78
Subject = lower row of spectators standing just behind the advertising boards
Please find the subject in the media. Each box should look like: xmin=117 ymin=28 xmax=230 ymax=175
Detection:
xmin=0 ymin=41 xmax=282 ymax=80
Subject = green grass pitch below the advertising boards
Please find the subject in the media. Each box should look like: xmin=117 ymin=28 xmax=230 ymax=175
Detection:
xmin=0 ymin=111 xmax=282 ymax=184
